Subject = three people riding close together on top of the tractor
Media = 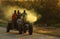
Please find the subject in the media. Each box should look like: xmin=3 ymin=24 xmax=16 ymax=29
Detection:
xmin=12 ymin=10 xmax=27 ymax=26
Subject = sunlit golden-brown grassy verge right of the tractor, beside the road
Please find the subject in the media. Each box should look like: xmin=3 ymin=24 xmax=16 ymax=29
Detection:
xmin=35 ymin=27 xmax=60 ymax=37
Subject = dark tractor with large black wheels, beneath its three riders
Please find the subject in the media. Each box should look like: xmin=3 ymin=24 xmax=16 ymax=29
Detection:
xmin=7 ymin=21 xmax=33 ymax=35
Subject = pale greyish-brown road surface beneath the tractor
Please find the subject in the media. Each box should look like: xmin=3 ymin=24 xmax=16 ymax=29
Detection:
xmin=0 ymin=27 xmax=60 ymax=39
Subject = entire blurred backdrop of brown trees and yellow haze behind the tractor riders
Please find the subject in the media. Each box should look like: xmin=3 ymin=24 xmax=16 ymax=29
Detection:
xmin=0 ymin=0 xmax=60 ymax=27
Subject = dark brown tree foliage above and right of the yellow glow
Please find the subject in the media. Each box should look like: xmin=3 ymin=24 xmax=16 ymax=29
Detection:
xmin=3 ymin=0 xmax=60 ymax=24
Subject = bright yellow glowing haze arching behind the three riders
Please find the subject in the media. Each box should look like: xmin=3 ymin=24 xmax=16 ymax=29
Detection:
xmin=4 ymin=6 xmax=38 ymax=23
